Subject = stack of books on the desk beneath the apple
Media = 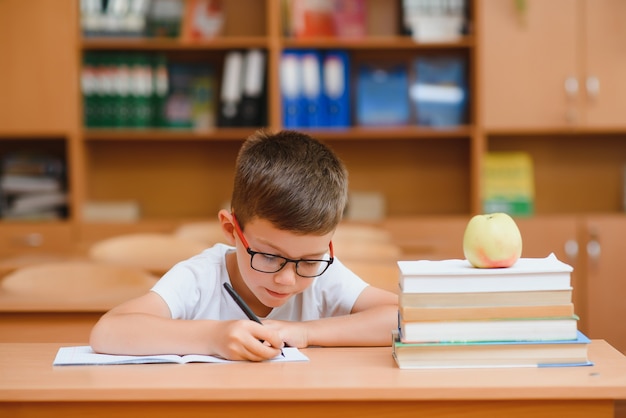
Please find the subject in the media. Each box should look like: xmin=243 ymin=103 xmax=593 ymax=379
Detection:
xmin=392 ymin=254 xmax=591 ymax=368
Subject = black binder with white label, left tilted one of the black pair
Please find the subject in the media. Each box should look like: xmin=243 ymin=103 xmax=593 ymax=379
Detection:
xmin=218 ymin=51 xmax=244 ymax=126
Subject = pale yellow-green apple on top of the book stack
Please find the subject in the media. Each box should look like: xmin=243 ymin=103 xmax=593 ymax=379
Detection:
xmin=463 ymin=212 xmax=522 ymax=268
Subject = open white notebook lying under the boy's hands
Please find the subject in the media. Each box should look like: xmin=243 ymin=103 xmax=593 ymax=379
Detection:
xmin=52 ymin=345 xmax=309 ymax=366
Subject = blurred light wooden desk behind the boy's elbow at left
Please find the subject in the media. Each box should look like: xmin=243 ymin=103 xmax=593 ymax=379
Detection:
xmin=0 ymin=261 xmax=156 ymax=343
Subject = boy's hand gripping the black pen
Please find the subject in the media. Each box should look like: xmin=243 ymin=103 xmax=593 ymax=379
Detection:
xmin=215 ymin=320 xmax=283 ymax=361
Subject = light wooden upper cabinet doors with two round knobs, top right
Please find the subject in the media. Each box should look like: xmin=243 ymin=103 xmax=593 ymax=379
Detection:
xmin=478 ymin=0 xmax=626 ymax=130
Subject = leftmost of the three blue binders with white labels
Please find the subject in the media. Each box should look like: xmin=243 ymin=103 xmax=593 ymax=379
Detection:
xmin=280 ymin=49 xmax=306 ymax=128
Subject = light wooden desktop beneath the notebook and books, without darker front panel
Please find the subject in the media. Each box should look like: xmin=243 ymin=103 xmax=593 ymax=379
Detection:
xmin=0 ymin=340 xmax=626 ymax=403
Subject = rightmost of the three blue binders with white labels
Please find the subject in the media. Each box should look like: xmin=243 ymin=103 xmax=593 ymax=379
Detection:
xmin=323 ymin=51 xmax=350 ymax=128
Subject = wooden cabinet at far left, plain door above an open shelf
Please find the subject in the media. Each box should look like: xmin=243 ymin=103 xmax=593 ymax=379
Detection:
xmin=0 ymin=0 xmax=82 ymax=251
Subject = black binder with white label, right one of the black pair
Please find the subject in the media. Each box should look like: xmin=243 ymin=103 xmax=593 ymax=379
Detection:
xmin=239 ymin=49 xmax=266 ymax=126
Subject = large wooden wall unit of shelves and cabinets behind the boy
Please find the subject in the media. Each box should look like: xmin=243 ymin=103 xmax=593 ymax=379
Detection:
xmin=0 ymin=0 xmax=626 ymax=356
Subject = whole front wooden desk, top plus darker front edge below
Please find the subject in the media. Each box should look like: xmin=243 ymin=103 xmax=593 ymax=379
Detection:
xmin=0 ymin=340 xmax=626 ymax=418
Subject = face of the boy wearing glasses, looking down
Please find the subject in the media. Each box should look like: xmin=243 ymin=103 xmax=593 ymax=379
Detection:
xmin=235 ymin=218 xmax=333 ymax=309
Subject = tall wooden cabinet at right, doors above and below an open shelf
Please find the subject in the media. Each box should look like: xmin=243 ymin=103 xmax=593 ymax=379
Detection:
xmin=477 ymin=0 xmax=626 ymax=351
